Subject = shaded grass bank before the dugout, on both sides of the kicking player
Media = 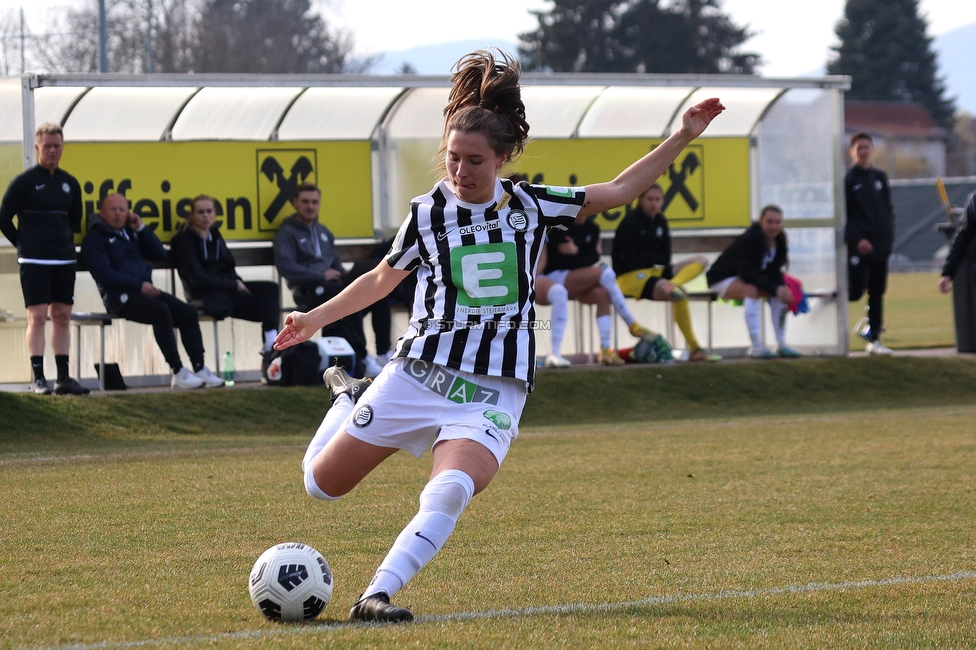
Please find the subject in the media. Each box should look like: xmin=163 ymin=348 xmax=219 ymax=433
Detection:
xmin=0 ymin=357 xmax=976 ymax=443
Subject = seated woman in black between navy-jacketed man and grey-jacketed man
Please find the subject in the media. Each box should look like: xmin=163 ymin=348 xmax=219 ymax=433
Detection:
xmin=170 ymin=194 xmax=281 ymax=354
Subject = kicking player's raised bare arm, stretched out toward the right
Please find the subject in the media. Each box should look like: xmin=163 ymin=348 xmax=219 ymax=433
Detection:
xmin=577 ymin=97 xmax=725 ymax=221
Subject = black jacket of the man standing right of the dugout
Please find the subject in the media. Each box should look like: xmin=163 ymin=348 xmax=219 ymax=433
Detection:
xmin=844 ymin=165 xmax=895 ymax=260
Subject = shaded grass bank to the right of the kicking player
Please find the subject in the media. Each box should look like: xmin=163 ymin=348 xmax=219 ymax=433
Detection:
xmin=521 ymin=357 xmax=976 ymax=426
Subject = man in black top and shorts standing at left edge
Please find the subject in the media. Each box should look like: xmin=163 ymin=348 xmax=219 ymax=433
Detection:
xmin=0 ymin=123 xmax=89 ymax=395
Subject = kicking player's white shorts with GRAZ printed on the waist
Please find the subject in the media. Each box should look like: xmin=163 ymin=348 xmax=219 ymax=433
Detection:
xmin=342 ymin=358 xmax=526 ymax=466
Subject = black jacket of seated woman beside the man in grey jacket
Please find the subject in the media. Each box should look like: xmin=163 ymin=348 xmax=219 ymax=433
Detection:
xmin=169 ymin=225 xmax=241 ymax=318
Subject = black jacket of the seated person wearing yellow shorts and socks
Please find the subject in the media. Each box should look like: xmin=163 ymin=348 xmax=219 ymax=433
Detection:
xmin=612 ymin=206 xmax=674 ymax=279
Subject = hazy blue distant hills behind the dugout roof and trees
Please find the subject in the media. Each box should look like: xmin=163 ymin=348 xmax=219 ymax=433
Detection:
xmin=371 ymin=23 xmax=976 ymax=116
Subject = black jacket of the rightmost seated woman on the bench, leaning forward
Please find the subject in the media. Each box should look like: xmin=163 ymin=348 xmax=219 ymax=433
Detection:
xmin=705 ymin=223 xmax=789 ymax=296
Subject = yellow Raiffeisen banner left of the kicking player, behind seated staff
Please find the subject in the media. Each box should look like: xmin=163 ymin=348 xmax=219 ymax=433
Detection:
xmin=61 ymin=141 xmax=373 ymax=243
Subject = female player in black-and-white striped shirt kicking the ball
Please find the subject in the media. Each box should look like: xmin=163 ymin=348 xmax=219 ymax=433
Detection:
xmin=275 ymin=50 xmax=725 ymax=622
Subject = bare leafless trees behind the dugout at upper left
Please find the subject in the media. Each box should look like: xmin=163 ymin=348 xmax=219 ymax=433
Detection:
xmin=0 ymin=0 xmax=371 ymax=74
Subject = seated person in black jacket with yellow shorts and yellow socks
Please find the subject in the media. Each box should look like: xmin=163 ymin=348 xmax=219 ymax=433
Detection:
xmin=612 ymin=183 xmax=722 ymax=361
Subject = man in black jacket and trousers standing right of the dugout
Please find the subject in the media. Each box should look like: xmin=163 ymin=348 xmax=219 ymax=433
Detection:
xmin=844 ymin=133 xmax=895 ymax=355
